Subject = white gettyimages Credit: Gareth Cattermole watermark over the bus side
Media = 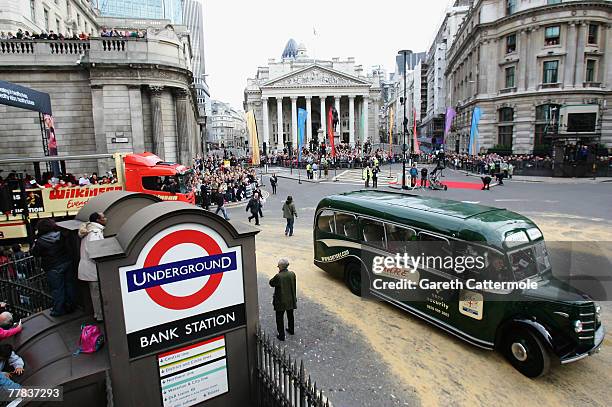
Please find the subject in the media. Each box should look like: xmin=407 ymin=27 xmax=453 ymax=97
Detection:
xmin=372 ymin=253 xmax=538 ymax=291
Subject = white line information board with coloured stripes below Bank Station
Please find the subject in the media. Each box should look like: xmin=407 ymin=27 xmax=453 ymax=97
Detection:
xmin=157 ymin=336 xmax=229 ymax=407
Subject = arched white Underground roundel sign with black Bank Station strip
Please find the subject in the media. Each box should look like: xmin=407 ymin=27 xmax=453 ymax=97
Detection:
xmin=119 ymin=224 xmax=246 ymax=358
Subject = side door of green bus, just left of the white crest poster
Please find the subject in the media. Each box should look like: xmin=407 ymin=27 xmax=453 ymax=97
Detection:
xmin=418 ymin=232 xmax=458 ymax=325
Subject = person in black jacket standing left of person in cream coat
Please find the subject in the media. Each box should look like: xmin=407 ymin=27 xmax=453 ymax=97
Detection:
xmin=31 ymin=218 xmax=75 ymax=317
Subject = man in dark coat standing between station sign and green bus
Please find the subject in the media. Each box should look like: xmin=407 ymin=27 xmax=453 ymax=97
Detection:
xmin=270 ymin=259 xmax=297 ymax=341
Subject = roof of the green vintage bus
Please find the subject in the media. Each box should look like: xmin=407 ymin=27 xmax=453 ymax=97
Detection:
xmin=319 ymin=190 xmax=537 ymax=249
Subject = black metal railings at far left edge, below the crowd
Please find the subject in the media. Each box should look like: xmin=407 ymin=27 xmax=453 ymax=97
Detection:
xmin=0 ymin=253 xmax=53 ymax=321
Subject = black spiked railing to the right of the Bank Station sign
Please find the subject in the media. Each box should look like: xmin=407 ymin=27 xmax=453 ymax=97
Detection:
xmin=257 ymin=329 xmax=331 ymax=407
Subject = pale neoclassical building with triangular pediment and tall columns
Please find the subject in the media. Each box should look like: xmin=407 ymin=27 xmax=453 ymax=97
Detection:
xmin=244 ymin=40 xmax=380 ymax=153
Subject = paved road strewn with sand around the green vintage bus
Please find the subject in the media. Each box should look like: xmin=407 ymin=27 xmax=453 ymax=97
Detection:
xmin=222 ymin=174 xmax=612 ymax=407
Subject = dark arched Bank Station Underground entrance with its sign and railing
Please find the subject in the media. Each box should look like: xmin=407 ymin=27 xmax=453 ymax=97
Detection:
xmin=1 ymin=191 xmax=328 ymax=407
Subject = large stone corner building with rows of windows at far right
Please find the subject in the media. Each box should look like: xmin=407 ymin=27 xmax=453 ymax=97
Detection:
xmin=446 ymin=0 xmax=612 ymax=154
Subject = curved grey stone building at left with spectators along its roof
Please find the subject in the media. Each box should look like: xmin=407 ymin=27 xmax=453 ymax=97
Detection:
xmin=0 ymin=27 xmax=201 ymax=173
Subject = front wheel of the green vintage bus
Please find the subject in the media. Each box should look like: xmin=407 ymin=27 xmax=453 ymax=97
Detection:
xmin=503 ymin=328 xmax=550 ymax=378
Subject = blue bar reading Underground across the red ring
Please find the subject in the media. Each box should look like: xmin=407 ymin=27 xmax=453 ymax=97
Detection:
xmin=126 ymin=252 xmax=237 ymax=292
